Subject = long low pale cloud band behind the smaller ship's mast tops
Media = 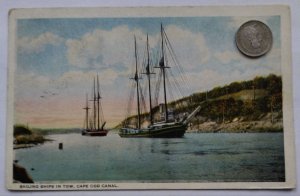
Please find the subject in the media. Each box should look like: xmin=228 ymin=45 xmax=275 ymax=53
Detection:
xmin=15 ymin=69 xmax=118 ymax=101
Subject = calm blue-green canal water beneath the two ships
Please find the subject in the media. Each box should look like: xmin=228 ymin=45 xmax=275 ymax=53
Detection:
xmin=14 ymin=133 xmax=285 ymax=182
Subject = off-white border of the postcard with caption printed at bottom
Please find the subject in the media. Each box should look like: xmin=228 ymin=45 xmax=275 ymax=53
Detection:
xmin=6 ymin=5 xmax=296 ymax=190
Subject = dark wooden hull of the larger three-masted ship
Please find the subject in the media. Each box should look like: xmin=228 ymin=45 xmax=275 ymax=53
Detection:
xmin=119 ymin=124 xmax=187 ymax=138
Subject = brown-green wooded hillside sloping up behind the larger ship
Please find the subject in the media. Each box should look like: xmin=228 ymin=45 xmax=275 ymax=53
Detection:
xmin=117 ymin=74 xmax=282 ymax=127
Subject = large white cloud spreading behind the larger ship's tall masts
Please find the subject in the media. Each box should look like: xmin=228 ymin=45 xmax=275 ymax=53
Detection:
xmin=66 ymin=25 xmax=210 ymax=73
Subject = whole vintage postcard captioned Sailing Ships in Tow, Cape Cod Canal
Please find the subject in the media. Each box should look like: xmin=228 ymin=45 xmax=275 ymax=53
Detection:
xmin=6 ymin=5 xmax=295 ymax=190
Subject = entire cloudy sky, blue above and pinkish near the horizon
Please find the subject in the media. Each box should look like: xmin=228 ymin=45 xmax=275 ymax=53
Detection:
xmin=14 ymin=16 xmax=281 ymax=128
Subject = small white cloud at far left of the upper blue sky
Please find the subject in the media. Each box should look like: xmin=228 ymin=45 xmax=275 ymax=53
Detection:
xmin=18 ymin=32 xmax=63 ymax=53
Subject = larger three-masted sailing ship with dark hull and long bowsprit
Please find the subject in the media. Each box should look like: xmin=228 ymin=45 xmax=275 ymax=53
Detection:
xmin=119 ymin=25 xmax=201 ymax=138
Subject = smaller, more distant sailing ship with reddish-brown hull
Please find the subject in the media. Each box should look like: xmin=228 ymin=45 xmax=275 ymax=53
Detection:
xmin=81 ymin=75 xmax=108 ymax=136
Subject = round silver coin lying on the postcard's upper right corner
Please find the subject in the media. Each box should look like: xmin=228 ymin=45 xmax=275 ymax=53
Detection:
xmin=235 ymin=20 xmax=273 ymax=57
